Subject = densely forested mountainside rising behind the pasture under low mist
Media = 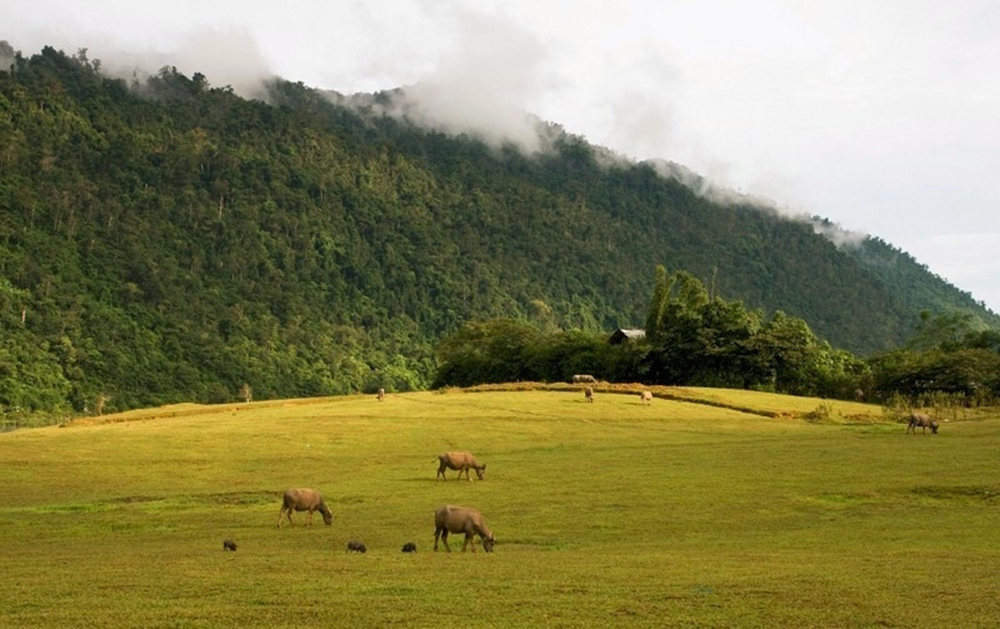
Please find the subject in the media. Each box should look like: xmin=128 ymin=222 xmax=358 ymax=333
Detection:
xmin=0 ymin=44 xmax=998 ymax=414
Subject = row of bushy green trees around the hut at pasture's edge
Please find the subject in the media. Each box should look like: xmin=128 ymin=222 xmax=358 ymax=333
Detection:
xmin=434 ymin=266 xmax=1000 ymax=406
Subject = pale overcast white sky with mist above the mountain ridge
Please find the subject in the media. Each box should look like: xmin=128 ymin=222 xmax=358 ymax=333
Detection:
xmin=0 ymin=0 xmax=1000 ymax=312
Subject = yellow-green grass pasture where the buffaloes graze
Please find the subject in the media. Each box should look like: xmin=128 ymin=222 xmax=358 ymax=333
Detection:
xmin=0 ymin=390 xmax=1000 ymax=628
